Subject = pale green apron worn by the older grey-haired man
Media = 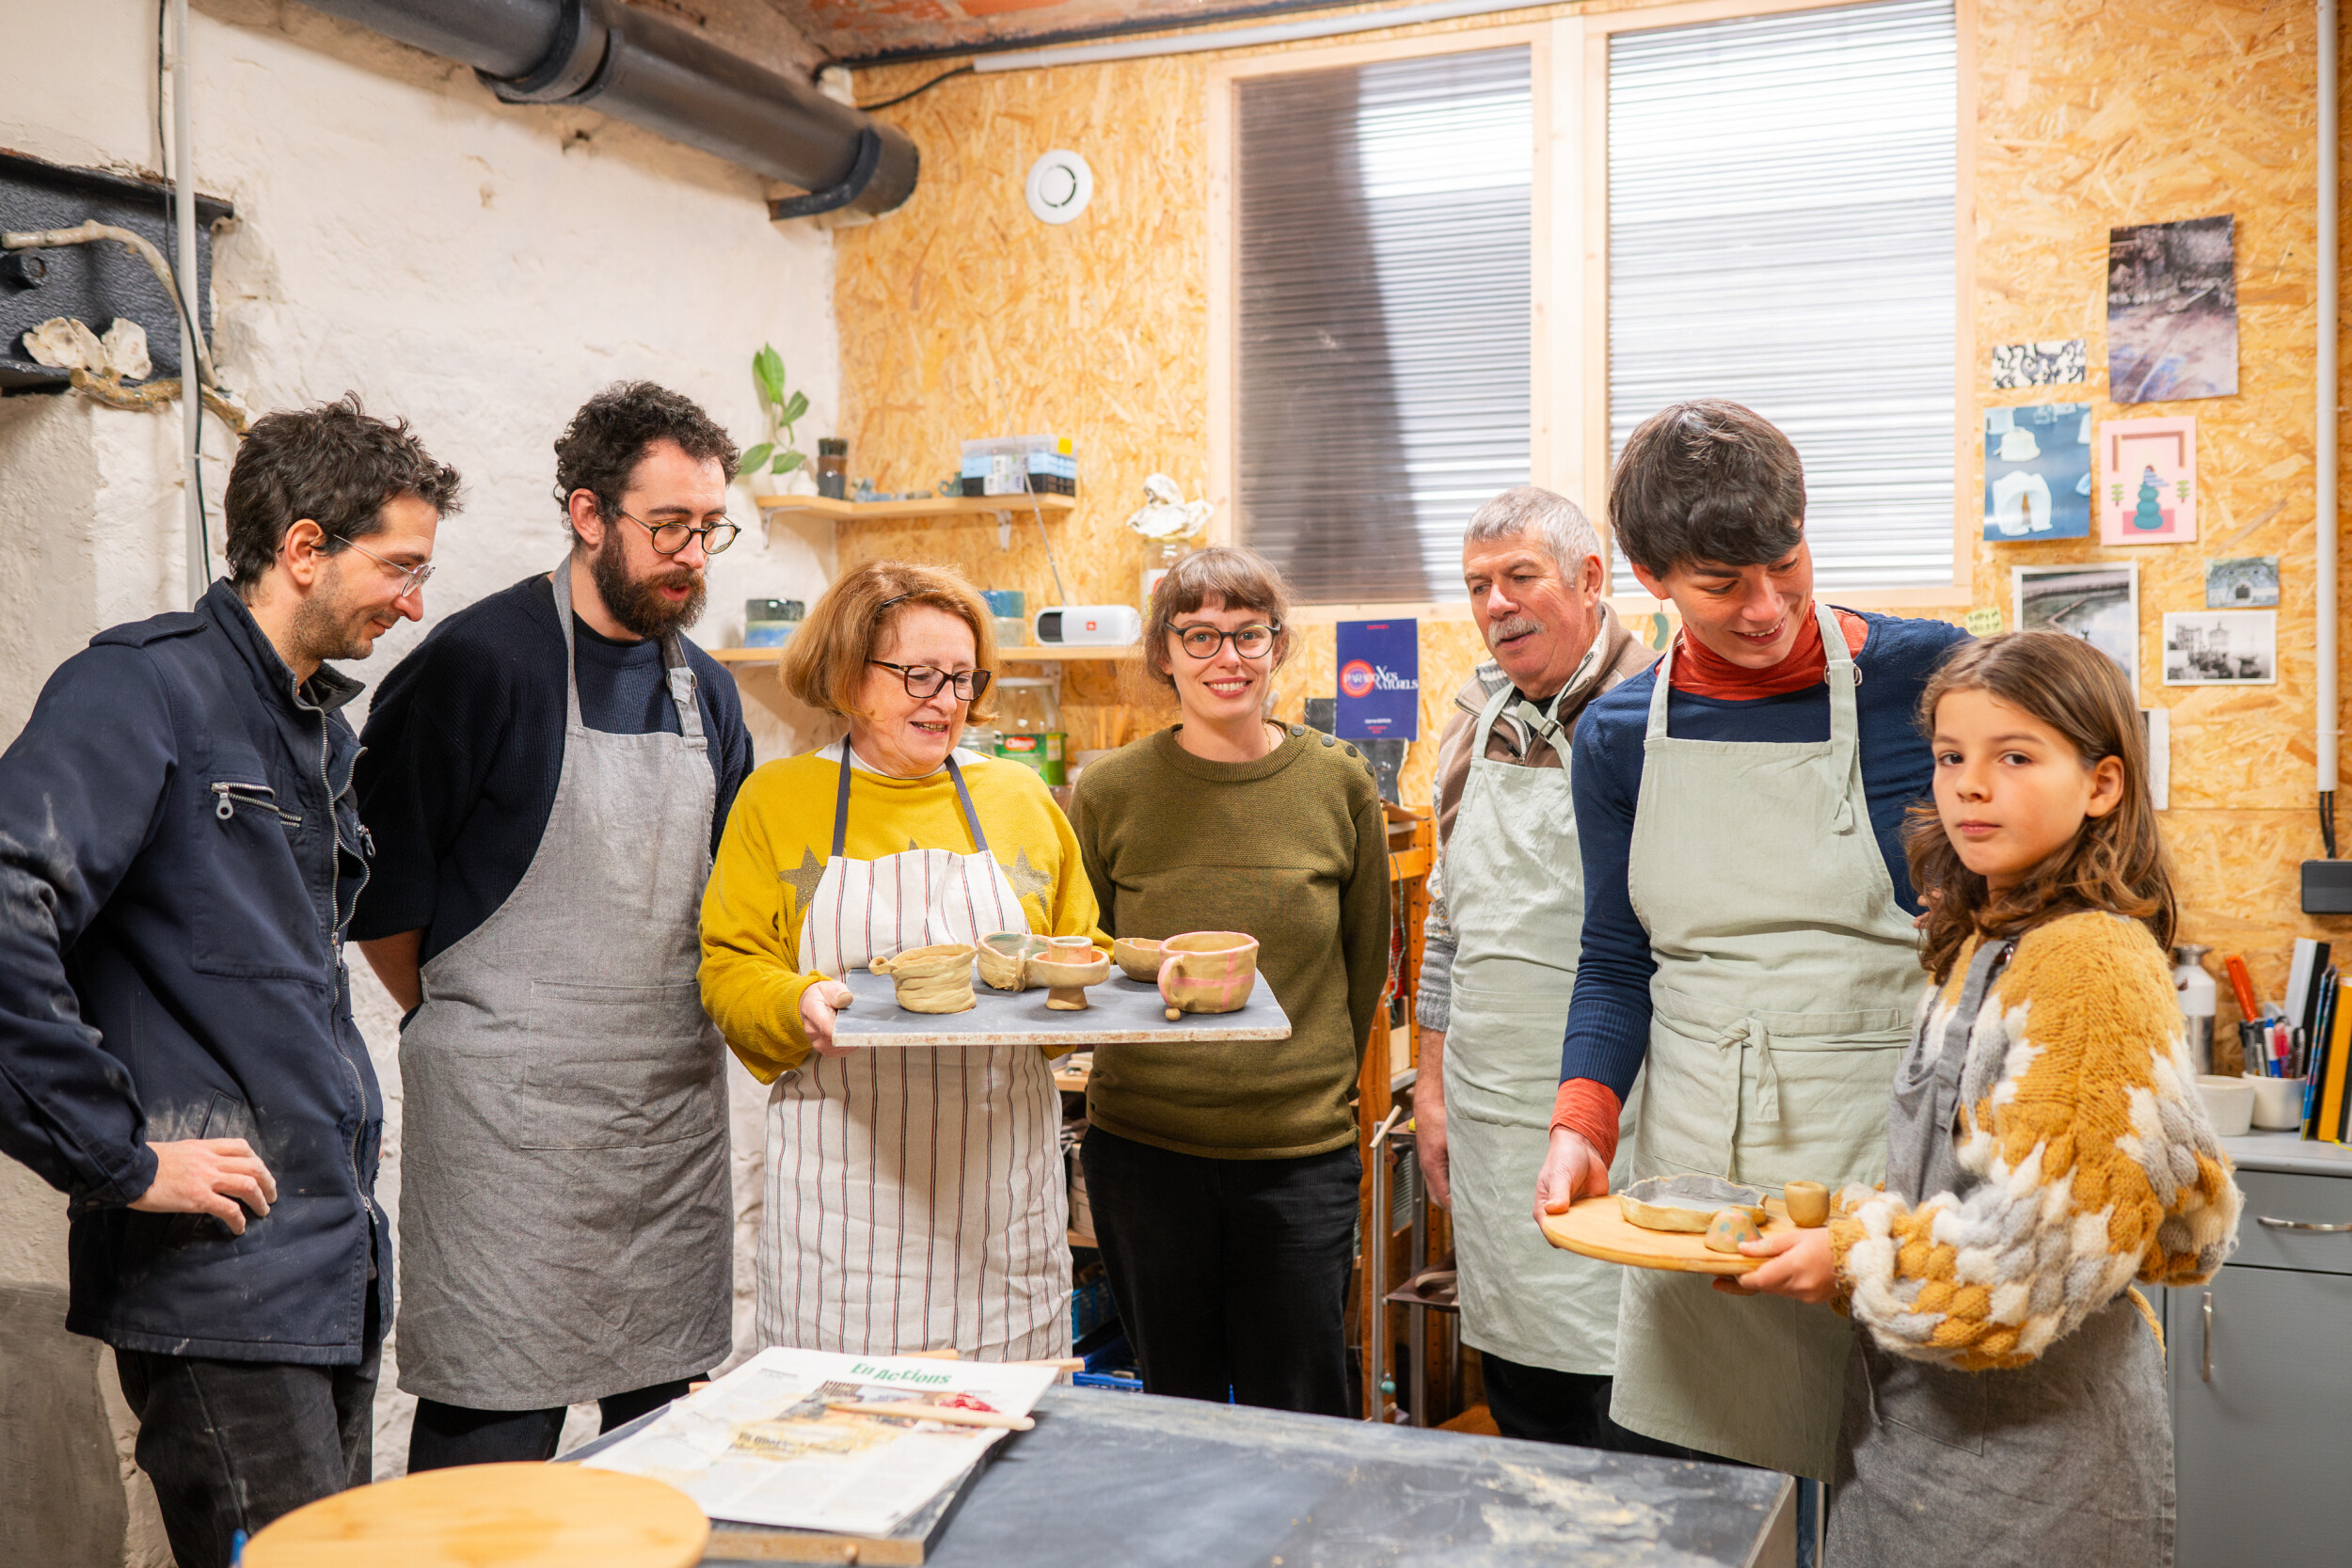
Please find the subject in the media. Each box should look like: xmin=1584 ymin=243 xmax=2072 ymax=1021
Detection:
xmin=1444 ymin=682 xmax=1642 ymax=1378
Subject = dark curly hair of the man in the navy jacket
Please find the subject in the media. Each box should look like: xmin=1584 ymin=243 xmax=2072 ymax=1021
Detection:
xmin=221 ymin=392 xmax=461 ymax=588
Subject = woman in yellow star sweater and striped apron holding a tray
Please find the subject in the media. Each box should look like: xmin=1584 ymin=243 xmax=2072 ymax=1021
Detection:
xmin=701 ymin=562 xmax=1108 ymax=1361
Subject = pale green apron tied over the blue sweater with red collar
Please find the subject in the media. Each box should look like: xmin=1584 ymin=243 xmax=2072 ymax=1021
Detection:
xmin=1609 ymin=599 xmax=1919 ymax=1481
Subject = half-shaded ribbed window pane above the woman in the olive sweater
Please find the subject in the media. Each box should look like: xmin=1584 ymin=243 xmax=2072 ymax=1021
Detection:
xmin=1235 ymin=44 xmax=1534 ymax=604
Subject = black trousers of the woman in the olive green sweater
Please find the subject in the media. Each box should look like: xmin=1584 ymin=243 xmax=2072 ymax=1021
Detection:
xmin=1080 ymin=1126 xmax=1362 ymax=1416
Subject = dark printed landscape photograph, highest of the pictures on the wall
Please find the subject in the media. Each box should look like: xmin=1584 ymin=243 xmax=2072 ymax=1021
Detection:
xmin=2107 ymin=214 xmax=2237 ymax=402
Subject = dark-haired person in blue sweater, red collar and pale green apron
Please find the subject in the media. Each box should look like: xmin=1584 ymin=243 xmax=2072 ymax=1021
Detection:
xmin=1536 ymin=400 xmax=1966 ymax=1481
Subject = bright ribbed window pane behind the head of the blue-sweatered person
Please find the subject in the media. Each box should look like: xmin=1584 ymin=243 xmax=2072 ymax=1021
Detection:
xmin=1609 ymin=0 xmax=1960 ymax=593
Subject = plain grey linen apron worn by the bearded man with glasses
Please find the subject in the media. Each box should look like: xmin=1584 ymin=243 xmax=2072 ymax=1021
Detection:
xmin=398 ymin=562 xmax=734 ymax=1411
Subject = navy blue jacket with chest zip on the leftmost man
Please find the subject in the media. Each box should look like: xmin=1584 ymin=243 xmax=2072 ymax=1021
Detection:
xmin=0 ymin=580 xmax=393 ymax=1366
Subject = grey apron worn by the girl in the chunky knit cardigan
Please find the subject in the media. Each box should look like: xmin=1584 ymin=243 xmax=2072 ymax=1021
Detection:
xmin=1828 ymin=942 xmax=2173 ymax=1568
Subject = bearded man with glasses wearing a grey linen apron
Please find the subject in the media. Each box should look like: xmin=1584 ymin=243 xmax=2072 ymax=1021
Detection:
xmin=353 ymin=381 xmax=753 ymax=1472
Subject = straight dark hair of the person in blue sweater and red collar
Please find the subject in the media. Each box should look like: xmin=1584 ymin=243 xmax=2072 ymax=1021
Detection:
xmin=1609 ymin=397 xmax=1804 ymax=578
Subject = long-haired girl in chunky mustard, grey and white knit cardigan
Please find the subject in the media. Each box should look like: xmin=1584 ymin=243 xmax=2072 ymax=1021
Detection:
xmin=1722 ymin=632 xmax=2239 ymax=1568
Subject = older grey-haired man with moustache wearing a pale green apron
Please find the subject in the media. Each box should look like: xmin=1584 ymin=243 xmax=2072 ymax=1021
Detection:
xmin=1414 ymin=484 xmax=1673 ymax=1453
